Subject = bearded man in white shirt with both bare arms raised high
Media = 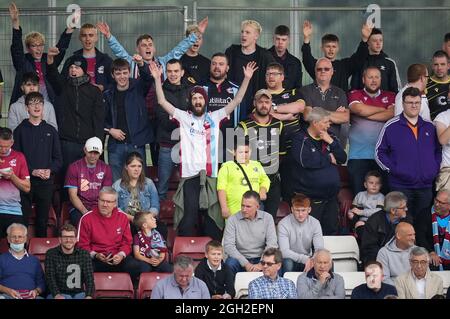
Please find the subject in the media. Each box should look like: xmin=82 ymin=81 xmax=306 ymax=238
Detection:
xmin=150 ymin=62 xmax=257 ymax=240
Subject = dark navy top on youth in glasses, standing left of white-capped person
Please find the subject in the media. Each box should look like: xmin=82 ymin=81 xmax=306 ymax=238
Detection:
xmin=13 ymin=119 xmax=62 ymax=180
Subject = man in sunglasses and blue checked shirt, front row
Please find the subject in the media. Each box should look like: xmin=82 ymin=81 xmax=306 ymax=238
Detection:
xmin=248 ymin=248 xmax=297 ymax=299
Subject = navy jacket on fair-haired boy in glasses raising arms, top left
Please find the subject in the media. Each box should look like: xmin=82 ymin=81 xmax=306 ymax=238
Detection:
xmin=9 ymin=27 xmax=72 ymax=105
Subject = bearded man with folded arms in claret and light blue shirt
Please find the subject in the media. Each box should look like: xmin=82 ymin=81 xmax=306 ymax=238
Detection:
xmin=347 ymin=66 xmax=395 ymax=194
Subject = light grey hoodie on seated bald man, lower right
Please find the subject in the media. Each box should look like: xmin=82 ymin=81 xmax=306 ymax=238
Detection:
xmin=377 ymin=236 xmax=416 ymax=285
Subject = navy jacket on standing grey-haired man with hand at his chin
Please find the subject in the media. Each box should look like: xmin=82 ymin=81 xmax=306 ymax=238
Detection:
xmin=291 ymin=130 xmax=347 ymax=200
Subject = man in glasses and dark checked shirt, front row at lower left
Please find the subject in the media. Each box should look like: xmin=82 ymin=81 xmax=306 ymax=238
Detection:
xmin=45 ymin=224 xmax=95 ymax=299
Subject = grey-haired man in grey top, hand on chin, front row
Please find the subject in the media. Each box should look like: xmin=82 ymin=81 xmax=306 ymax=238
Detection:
xmin=297 ymin=249 xmax=345 ymax=299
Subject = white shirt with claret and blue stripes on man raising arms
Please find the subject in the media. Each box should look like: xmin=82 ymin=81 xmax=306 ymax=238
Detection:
xmin=173 ymin=108 xmax=227 ymax=177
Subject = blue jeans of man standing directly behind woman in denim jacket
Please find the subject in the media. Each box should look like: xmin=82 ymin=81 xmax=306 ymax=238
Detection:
xmin=108 ymin=142 xmax=146 ymax=182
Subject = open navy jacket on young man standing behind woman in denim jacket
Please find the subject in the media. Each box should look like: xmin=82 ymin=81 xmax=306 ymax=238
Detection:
xmin=103 ymin=67 xmax=154 ymax=148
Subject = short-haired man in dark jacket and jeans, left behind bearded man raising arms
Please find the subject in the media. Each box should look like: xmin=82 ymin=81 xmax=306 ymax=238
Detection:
xmin=156 ymin=59 xmax=194 ymax=200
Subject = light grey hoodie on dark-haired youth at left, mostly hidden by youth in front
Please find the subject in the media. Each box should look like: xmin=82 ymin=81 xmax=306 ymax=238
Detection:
xmin=8 ymin=95 xmax=58 ymax=131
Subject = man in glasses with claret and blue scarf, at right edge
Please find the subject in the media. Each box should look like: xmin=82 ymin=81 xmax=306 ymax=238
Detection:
xmin=416 ymin=189 xmax=450 ymax=270
